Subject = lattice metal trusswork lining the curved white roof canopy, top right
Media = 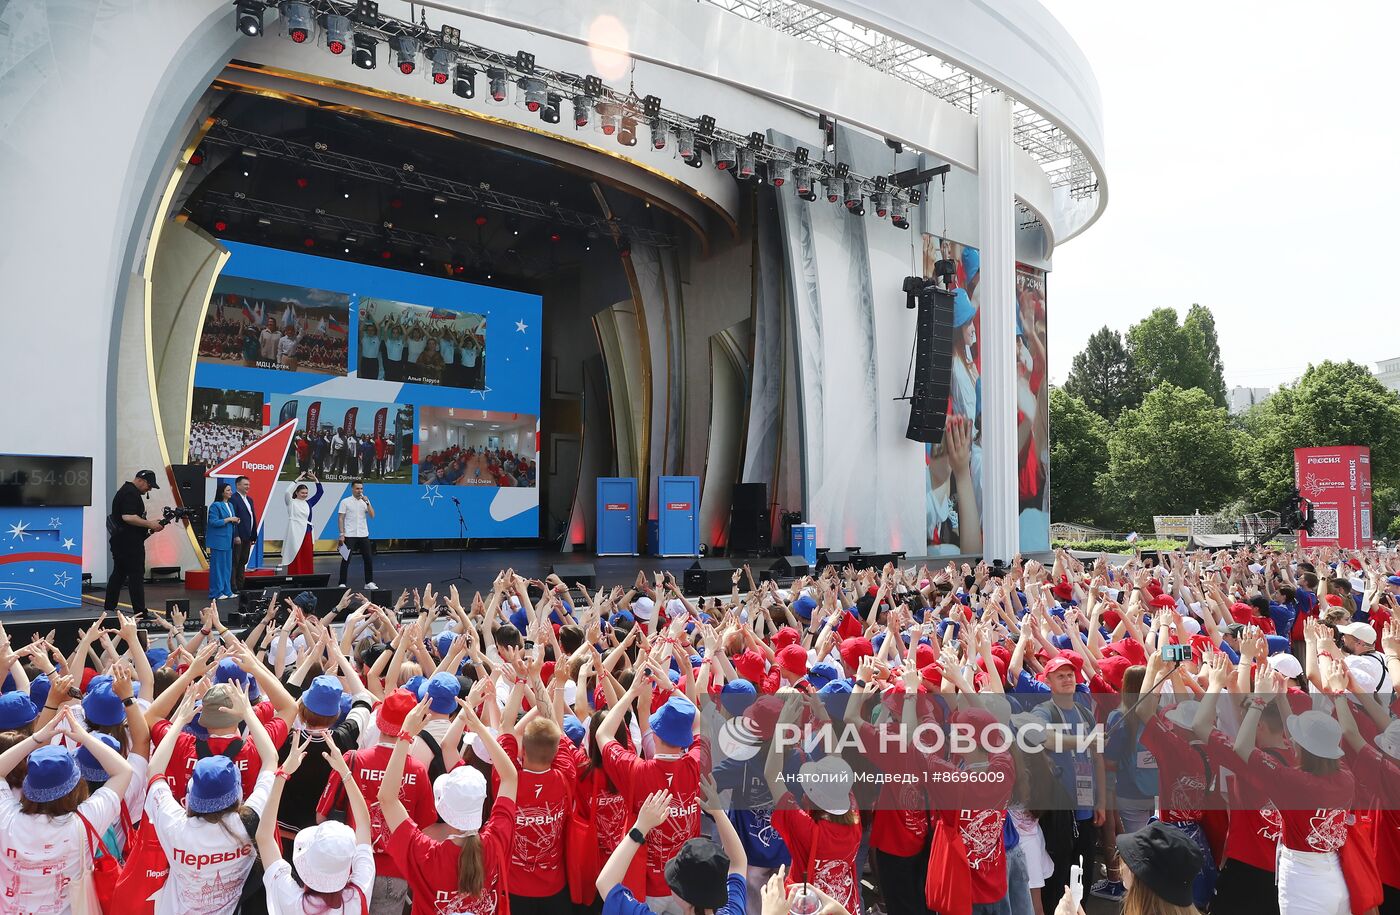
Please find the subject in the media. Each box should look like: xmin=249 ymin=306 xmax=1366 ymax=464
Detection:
xmin=703 ymin=0 xmax=1099 ymax=197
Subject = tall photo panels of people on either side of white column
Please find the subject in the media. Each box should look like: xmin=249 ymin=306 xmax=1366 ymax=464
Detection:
xmin=923 ymin=235 xmax=1050 ymax=555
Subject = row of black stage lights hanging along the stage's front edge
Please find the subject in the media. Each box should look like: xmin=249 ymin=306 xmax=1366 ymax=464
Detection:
xmin=235 ymin=0 xmax=923 ymax=229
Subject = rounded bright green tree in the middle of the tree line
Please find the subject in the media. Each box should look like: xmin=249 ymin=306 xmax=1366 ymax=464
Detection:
xmin=1097 ymin=382 xmax=1240 ymax=527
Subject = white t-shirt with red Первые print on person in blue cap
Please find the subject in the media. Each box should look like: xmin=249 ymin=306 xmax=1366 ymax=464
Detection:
xmin=146 ymin=768 xmax=273 ymax=915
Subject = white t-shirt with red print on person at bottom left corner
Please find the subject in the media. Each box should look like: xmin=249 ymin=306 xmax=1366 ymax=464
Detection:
xmin=0 ymin=786 xmax=122 ymax=915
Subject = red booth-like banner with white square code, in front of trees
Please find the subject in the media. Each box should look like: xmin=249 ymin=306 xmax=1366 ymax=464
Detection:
xmin=1294 ymin=446 xmax=1371 ymax=550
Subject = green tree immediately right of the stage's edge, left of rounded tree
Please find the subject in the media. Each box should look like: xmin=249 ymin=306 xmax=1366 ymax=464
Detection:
xmin=1050 ymin=388 xmax=1117 ymax=525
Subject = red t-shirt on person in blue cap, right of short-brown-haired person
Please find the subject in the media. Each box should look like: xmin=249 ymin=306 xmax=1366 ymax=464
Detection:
xmin=603 ymin=736 xmax=710 ymax=895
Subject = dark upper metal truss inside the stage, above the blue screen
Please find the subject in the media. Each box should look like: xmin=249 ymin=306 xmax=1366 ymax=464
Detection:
xmin=204 ymin=120 xmax=676 ymax=248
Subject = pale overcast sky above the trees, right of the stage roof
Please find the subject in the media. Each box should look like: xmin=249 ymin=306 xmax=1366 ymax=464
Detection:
xmin=1042 ymin=0 xmax=1400 ymax=388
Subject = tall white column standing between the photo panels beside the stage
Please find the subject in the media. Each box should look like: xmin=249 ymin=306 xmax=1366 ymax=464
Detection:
xmin=977 ymin=92 xmax=1021 ymax=562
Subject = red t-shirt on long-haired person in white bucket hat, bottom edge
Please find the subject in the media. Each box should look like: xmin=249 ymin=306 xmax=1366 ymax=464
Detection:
xmin=389 ymin=797 xmax=515 ymax=915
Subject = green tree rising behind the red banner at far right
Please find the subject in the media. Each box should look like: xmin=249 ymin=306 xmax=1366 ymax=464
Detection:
xmin=1243 ymin=362 xmax=1400 ymax=533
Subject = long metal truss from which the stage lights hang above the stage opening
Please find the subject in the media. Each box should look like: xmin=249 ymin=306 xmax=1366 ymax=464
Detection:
xmin=237 ymin=0 xmax=920 ymax=206
